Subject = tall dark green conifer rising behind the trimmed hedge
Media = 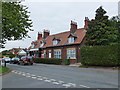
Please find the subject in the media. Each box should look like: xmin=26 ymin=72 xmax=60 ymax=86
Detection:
xmin=86 ymin=6 xmax=118 ymax=46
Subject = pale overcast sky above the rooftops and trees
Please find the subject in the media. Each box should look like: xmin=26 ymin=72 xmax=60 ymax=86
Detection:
xmin=0 ymin=0 xmax=118 ymax=51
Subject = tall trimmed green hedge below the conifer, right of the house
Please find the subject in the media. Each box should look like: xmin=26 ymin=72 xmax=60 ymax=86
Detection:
xmin=81 ymin=45 xmax=120 ymax=66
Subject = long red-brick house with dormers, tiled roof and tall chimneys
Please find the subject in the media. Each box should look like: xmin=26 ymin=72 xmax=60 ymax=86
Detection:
xmin=29 ymin=17 xmax=88 ymax=63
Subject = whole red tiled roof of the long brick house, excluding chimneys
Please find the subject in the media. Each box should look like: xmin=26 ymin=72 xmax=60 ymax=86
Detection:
xmin=28 ymin=28 xmax=86 ymax=50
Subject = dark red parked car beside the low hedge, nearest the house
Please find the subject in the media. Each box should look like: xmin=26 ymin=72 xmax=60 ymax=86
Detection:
xmin=18 ymin=56 xmax=33 ymax=65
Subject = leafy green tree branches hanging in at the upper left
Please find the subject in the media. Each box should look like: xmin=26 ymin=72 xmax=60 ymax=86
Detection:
xmin=1 ymin=2 xmax=32 ymax=47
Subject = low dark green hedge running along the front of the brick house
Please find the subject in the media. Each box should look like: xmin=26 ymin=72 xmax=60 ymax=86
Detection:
xmin=33 ymin=58 xmax=62 ymax=65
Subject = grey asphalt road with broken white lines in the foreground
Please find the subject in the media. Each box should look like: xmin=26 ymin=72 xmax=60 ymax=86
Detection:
xmin=2 ymin=64 xmax=118 ymax=88
